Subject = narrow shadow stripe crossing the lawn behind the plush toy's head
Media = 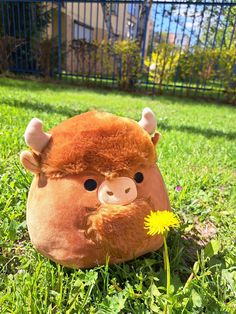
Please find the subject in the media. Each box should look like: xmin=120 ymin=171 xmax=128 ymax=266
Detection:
xmin=4 ymin=99 xmax=236 ymax=140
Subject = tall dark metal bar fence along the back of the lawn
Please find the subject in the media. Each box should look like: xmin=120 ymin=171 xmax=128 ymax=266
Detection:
xmin=0 ymin=0 xmax=236 ymax=102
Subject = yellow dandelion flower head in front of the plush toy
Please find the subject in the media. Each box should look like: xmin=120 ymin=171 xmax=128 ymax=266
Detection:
xmin=144 ymin=210 xmax=180 ymax=236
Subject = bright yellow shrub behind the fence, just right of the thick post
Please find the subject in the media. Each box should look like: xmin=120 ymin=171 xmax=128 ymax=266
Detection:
xmin=145 ymin=43 xmax=180 ymax=88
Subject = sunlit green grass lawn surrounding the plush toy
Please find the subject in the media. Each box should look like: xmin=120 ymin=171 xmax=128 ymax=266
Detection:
xmin=0 ymin=78 xmax=236 ymax=314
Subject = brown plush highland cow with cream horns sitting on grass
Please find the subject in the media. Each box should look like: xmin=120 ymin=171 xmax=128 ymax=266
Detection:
xmin=20 ymin=108 xmax=170 ymax=268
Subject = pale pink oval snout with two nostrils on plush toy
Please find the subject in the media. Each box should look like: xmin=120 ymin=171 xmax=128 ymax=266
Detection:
xmin=98 ymin=177 xmax=137 ymax=205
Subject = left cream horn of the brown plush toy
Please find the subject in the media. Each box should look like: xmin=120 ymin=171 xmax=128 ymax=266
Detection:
xmin=24 ymin=118 xmax=51 ymax=154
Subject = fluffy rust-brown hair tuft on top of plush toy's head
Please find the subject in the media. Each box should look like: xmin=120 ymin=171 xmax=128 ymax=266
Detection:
xmin=41 ymin=111 xmax=156 ymax=176
